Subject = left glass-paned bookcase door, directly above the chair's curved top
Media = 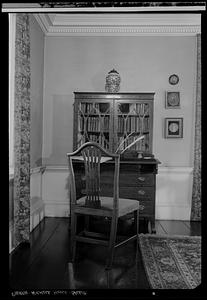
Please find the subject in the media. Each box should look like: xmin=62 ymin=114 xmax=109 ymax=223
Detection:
xmin=75 ymin=100 xmax=113 ymax=151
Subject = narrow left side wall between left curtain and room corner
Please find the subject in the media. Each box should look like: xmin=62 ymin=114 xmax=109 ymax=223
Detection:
xmin=30 ymin=15 xmax=44 ymax=231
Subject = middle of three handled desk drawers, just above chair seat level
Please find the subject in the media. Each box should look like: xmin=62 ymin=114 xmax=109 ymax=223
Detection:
xmin=119 ymin=186 xmax=154 ymax=201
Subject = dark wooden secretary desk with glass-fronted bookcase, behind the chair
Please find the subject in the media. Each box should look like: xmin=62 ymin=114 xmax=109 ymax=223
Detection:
xmin=73 ymin=92 xmax=160 ymax=233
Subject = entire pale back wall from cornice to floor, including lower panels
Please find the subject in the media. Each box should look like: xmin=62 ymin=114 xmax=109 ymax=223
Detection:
xmin=42 ymin=36 xmax=196 ymax=220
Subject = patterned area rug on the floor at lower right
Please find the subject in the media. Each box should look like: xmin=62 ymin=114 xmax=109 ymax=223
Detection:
xmin=139 ymin=234 xmax=201 ymax=289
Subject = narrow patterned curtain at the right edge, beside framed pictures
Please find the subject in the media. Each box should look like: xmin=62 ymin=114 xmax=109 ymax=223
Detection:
xmin=191 ymin=34 xmax=201 ymax=221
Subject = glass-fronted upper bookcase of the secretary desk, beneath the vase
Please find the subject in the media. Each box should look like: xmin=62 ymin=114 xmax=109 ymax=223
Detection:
xmin=73 ymin=92 xmax=154 ymax=154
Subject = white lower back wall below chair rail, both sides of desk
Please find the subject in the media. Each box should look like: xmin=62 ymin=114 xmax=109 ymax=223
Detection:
xmin=42 ymin=165 xmax=193 ymax=220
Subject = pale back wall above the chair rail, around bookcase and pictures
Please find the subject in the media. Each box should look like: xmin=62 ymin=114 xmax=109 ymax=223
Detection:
xmin=43 ymin=36 xmax=196 ymax=166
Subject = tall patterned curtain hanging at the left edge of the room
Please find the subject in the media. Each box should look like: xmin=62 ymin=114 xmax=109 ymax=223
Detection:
xmin=14 ymin=13 xmax=30 ymax=247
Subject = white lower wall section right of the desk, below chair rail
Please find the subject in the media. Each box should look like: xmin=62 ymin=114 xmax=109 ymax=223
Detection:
xmin=155 ymin=167 xmax=193 ymax=221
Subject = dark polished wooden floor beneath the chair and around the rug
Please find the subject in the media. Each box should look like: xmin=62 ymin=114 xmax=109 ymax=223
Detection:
xmin=10 ymin=218 xmax=201 ymax=290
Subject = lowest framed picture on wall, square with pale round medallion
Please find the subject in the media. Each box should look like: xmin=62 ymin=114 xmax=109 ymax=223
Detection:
xmin=165 ymin=118 xmax=183 ymax=139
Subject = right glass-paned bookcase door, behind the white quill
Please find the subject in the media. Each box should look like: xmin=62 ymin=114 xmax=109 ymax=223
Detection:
xmin=114 ymin=99 xmax=152 ymax=153
